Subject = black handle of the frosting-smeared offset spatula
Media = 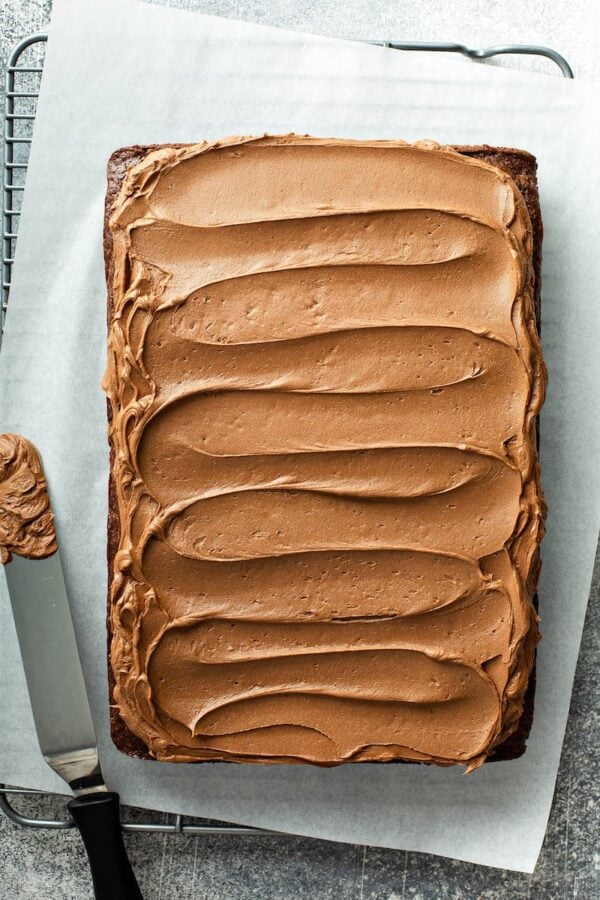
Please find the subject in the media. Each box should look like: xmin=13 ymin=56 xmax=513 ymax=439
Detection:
xmin=67 ymin=791 xmax=143 ymax=900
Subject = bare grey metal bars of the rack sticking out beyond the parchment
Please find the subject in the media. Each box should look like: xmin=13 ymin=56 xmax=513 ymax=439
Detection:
xmin=0 ymin=33 xmax=574 ymax=837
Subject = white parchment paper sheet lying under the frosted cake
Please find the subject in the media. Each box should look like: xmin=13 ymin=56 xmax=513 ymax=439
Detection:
xmin=0 ymin=0 xmax=600 ymax=872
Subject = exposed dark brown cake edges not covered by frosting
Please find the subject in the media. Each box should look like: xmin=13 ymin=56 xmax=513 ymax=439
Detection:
xmin=103 ymin=144 xmax=543 ymax=765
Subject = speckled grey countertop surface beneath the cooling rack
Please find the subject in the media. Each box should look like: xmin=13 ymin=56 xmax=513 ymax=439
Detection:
xmin=0 ymin=0 xmax=600 ymax=900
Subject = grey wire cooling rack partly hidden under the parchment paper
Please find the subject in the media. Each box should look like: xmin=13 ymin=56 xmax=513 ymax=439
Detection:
xmin=0 ymin=34 xmax=574 ymax=835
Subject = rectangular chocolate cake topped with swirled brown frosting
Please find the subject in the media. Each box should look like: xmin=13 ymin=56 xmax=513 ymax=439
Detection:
xmin=104 ymin=135 xmax=546 ymax=770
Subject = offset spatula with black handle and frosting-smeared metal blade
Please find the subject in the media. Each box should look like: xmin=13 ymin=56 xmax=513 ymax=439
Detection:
xmin=0 ymin=434 xmax=142 ymax=900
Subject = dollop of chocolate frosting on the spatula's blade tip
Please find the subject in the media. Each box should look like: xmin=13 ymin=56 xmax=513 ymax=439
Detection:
xmin=0 ymin=434 xmax=58 ymax=563
